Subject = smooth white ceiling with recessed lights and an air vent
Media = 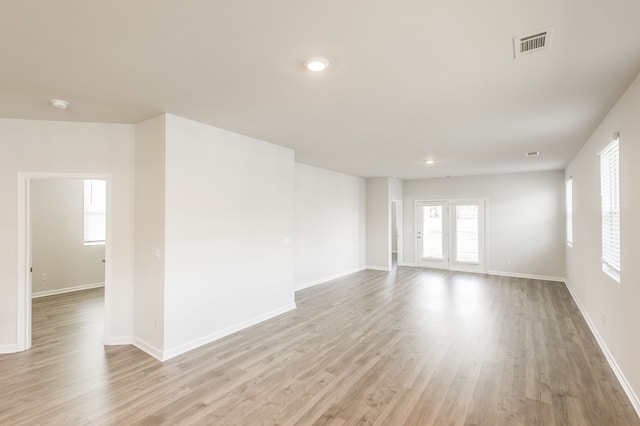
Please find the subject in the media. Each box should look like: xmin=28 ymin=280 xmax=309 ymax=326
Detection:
xmin=0 ymin=0 xmax=640 ymax=179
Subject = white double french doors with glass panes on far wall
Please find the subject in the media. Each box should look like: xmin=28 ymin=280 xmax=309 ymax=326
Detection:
xmin=416 ymin=200 xmax=485 ymax=272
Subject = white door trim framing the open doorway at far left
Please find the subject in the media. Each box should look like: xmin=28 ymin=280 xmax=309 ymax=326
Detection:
xmin=16 ymin=172 xmax=112 ymax=352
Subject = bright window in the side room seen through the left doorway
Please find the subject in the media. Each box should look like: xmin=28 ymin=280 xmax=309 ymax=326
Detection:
xmin=84 ymin=180 xmax=107 ymax=245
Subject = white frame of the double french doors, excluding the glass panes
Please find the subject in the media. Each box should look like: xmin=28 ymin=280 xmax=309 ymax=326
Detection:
xmin=414 ymin=198 xmax=489 ymax=273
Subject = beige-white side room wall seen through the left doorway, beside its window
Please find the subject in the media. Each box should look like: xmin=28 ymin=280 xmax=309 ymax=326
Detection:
xmin=30 ymin=179 xmax=105 ymax=296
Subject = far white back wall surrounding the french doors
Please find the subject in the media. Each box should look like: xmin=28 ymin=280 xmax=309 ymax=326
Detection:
xmin=404 ymin=171 xmax=565 ymax=280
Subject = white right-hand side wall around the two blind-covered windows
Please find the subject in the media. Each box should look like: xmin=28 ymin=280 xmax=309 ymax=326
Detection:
xmin=566 ymin=71 xmax=640 ymax=413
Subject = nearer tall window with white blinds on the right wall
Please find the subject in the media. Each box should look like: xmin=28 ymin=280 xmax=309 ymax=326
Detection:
xmin=600 ymin=136 xmax=620 ymax=282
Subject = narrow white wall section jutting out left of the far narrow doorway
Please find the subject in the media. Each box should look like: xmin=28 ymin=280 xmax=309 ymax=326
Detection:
xmin=366 ymin=178 xmax=391 ymax=271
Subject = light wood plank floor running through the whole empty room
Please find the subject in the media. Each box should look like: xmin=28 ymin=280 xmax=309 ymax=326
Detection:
xmin=0 ymin=267 xmax=640 ymax=426
